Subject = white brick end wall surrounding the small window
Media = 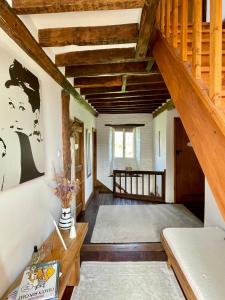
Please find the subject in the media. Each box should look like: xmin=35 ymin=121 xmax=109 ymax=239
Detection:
xmin=96 ymin=114 xmax=153 ymax=189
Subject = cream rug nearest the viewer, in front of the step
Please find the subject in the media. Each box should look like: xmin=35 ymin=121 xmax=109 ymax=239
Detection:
xmin=71 ymin=262 xmax=185 ymax=300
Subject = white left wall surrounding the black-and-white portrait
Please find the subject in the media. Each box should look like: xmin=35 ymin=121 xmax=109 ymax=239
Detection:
xmin=0 ymin=30 xmax=61 ymax=297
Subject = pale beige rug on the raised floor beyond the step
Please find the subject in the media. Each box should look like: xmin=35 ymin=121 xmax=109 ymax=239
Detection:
xmin=91 ymin=204 xmax=203 ymax=243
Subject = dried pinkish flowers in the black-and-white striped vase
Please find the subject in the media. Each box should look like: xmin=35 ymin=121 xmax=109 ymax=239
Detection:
xmin=54 ymin=170 xmax=80 ymax=208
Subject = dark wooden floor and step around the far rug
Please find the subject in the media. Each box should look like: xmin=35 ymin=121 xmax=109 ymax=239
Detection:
xmin=62 ymin=193 xmax=204 ymax=300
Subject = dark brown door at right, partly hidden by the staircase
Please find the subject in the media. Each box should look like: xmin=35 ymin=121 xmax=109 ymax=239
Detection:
xmin=174 ymin=118 xmax=205 ymax=219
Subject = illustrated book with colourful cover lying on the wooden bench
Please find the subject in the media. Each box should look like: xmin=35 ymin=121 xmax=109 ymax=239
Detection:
xmin=16 ymin=261 xmax=59 ymax=300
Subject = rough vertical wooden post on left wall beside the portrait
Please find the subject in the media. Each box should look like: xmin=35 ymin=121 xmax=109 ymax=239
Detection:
xmin=62 ymin=90 xmax=71 ymax=179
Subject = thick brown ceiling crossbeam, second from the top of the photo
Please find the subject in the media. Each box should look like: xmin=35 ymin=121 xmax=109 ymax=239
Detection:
xmin=38 ymin=24 xmax=138 ymax=47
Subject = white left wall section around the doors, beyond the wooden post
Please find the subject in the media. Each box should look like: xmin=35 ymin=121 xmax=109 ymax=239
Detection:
xmin=70 ymin=97 xmax=96 ymax=202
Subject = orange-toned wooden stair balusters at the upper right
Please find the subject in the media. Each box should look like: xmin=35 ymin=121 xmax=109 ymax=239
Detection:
xmin=157 ymin=0 xmax=224 ymax=108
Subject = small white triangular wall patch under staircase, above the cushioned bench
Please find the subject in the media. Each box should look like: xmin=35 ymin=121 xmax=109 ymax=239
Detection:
xmin=204 ymin=179 xmax=225 ymax=230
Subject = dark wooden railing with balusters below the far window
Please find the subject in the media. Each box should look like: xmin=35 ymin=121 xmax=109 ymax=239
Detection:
xmin=113 ymin=170 xmax=166 ymax=202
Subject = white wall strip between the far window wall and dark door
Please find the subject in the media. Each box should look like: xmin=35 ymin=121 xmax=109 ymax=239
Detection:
xmin=153 ymin=109 xmax=179 ymax=203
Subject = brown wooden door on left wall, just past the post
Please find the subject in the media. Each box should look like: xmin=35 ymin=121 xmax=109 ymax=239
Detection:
xmin=73 ymin=119 xmax=85 ymax=216
